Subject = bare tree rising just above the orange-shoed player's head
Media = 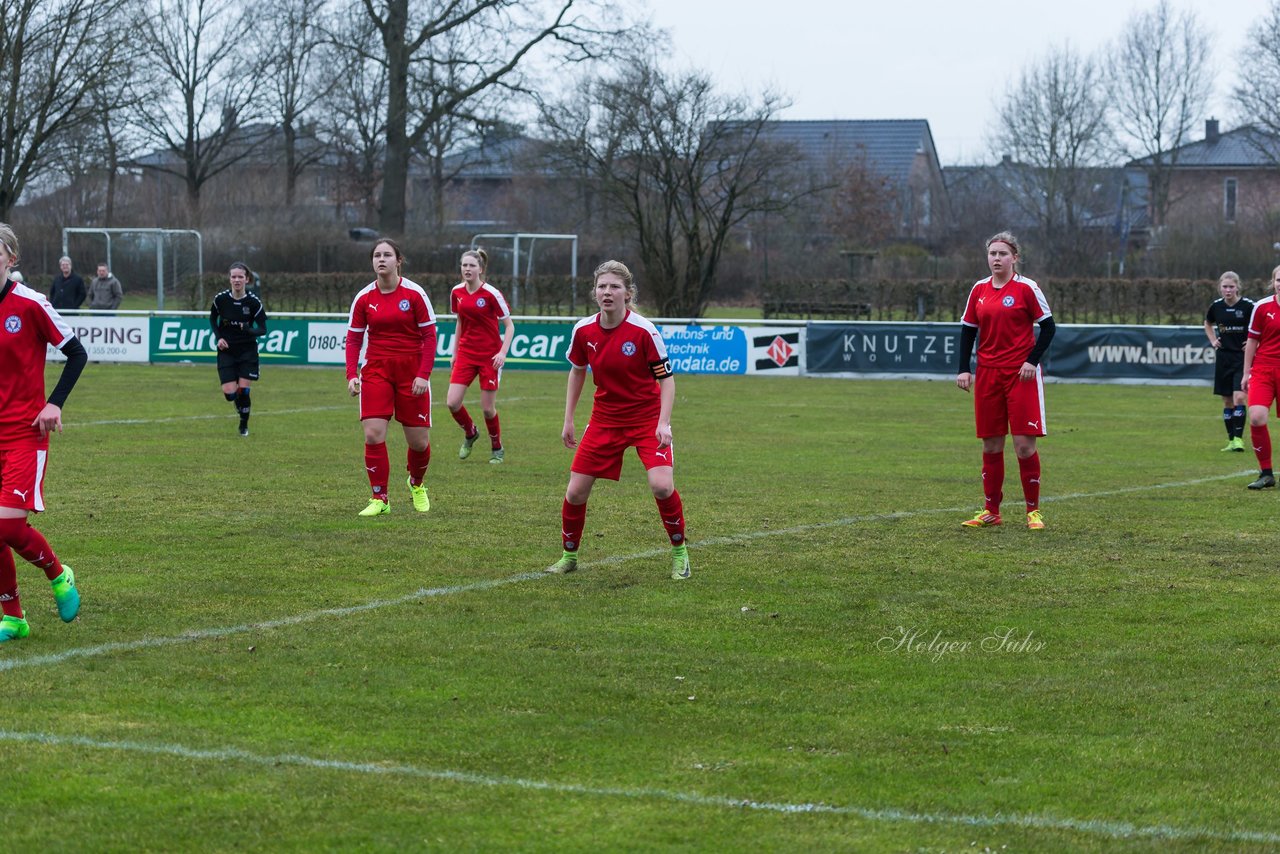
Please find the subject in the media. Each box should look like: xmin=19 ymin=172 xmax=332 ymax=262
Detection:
xmin=993 ymin=46 xmax=1108 ymax=270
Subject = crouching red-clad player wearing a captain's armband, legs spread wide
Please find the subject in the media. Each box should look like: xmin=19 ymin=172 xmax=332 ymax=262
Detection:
xmin=547 ymin=261 xmax=690 ymax=579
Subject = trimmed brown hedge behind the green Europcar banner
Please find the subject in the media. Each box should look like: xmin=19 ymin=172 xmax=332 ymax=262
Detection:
xmin=177 ymin=273 xmax=586 ymax=315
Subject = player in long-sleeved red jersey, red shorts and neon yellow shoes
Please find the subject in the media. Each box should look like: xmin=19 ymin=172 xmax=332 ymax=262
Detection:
xmin=347 ymin=238 xmax=435 ymax=516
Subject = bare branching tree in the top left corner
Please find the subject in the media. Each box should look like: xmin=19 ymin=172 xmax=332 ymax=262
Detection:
xmin=0 ymin=0 xmax=123 ymax=220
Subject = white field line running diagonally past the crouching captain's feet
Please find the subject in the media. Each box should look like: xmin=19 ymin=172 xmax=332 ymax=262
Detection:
xmin=0 ymin=471 xmax=1251 ymax=672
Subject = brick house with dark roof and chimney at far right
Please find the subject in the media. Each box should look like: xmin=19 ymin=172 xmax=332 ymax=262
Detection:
xmin=1125 ymin=119 xmax=1280 ymax=232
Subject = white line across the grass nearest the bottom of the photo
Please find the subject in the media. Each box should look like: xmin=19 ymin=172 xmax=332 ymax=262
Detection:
xmin=0 ymin=730 xmax=1280 ymax=844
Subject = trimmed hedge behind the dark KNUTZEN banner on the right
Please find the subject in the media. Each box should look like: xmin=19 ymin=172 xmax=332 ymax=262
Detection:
xmin=760 ymin=278 xmax=1233 ymax=325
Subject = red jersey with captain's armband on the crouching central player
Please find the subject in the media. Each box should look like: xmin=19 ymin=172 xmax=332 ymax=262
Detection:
xmin=568 ymin=311 xmax=671 ymax=426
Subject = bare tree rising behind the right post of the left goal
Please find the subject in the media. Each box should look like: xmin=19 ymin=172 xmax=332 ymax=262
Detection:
xmin=133 ymin=0 xmax=264 ymax=224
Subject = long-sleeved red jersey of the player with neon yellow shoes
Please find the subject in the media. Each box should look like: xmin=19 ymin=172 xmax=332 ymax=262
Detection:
xmin=347 ymin=278 xmax=435 ymax=379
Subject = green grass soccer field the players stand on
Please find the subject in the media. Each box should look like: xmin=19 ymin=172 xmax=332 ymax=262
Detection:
xmin=0 ymin=365 xmax=1280 ymax=851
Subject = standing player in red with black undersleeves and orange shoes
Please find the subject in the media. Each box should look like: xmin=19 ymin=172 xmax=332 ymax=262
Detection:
xmin=956 ymin=232 xmax=1055 ymax=530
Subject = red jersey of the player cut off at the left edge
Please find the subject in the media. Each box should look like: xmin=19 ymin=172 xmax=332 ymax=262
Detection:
xmin=0 ymin=282 xmax=76 ymax=444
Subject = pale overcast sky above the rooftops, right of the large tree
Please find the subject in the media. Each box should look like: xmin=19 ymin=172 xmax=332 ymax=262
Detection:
xmin=648 ymin=0 xmax=1264 ymax=165
